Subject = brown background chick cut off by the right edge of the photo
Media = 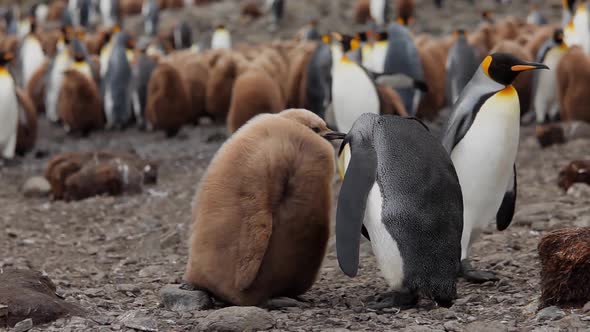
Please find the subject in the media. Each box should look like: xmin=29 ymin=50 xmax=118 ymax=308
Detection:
xmin=557 ymin=46 xmax=590 ymax=122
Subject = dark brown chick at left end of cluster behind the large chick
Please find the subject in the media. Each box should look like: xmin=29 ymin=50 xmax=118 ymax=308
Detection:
xmin=145 ymin=63 xmax=191 ymax=137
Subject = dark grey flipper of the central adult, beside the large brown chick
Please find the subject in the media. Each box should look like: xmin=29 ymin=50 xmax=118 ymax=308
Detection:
xmin=336 ymin=136 xmax=377 ymax=277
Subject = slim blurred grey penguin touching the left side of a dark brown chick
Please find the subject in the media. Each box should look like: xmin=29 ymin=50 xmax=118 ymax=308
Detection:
xmin=131 ymin=52 xmax=158 ymax=128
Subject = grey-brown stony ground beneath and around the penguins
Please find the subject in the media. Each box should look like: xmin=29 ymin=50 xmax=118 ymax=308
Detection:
xmin=0 ymin=0 xmax=590 ymax=331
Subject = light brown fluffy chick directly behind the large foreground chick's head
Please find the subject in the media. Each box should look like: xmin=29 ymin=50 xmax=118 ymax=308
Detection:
xmin=227 ymin=69 xmax=285 ymax=133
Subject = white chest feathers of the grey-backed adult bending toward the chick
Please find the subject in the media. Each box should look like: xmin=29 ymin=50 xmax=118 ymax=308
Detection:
xmin=363 ymin=183 xmax=404 ymax=290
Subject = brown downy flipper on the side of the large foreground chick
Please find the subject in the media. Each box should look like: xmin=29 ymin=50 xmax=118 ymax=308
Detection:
xmin=234 ymin=211 xmax=273 ymax=291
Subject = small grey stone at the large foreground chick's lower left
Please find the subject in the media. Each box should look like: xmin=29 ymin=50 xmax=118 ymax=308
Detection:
xmin=160 ymin=285 xmax=213 ymax=312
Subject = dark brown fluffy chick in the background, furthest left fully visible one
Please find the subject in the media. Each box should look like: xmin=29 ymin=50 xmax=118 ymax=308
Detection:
xmin=57 ymin=69 xmax=105 ymax=135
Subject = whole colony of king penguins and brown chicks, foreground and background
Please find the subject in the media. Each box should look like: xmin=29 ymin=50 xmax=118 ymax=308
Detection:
xmin=0 ymin=0 xmax=590 ymax=309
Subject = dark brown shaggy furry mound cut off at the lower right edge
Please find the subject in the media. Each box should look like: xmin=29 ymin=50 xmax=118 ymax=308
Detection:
xmin=538 ymin=227 xmax=590 ymax=307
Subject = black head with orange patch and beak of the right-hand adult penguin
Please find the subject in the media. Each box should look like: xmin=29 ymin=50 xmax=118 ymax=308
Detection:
xmin=481 ymin=53 xmax=549 ymax=85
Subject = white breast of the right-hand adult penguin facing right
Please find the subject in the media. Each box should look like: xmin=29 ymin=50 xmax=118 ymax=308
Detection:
xmin=451 ymin=87 xmax=520 ymax=258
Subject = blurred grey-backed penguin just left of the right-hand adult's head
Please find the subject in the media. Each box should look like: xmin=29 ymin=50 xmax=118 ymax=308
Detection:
xmin=446 ymin=30 xmax=479 ymax=105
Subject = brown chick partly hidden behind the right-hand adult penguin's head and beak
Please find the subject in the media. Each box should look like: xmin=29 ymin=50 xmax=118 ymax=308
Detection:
xmin=491 ymin=41 xmax=533 ymax=115
